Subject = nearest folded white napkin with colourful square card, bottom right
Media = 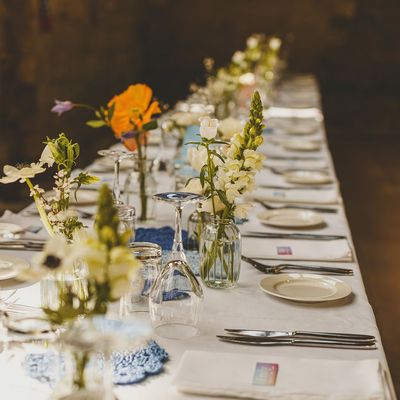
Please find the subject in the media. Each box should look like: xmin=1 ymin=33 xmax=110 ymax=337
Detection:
xmin=173 ymin=351 xmax=390 ymax=400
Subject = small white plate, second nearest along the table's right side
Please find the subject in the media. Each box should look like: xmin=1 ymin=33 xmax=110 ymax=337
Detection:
xmin=257 ymin=208 xmax=324 ymax=228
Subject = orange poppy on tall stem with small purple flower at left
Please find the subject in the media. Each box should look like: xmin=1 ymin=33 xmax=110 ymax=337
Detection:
xmin=51 ymin=83 xmax=161 ymax=220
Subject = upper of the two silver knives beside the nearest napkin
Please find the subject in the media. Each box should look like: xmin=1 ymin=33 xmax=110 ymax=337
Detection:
xmin=224 ymin=328 xmax=375 ymax=342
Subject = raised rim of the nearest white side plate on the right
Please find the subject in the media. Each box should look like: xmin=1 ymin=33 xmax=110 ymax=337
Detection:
xmin=259 ymin=273 xmax=353 ymax=303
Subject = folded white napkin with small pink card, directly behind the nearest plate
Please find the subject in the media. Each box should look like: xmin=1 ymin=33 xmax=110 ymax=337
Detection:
xmin=242 ymin=237 xmax=353 ymax=261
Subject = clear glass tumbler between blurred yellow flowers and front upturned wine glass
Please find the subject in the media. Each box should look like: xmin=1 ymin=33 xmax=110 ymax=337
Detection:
xmin=121 ymin=242 xmax=162 ymax=316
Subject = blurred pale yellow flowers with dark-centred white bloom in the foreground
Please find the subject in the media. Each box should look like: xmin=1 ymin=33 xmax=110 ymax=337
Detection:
xmin=26 ymin=185 xmax=141 ymax=324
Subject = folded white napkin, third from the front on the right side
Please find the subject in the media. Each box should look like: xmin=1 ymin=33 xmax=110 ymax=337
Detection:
xmin=252 ymin=187 xmax=339 ymax=204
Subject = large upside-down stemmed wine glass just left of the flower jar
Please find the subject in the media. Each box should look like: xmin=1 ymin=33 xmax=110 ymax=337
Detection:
xmin=149 ymin=192 xmax=203 ymax=339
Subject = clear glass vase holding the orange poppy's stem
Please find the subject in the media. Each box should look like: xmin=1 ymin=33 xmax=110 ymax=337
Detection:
xmin=124 ymin=158 xmax=157 ymax=222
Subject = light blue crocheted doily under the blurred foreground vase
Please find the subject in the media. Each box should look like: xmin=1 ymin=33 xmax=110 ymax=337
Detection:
xmin=24 ymin=340 xmax=168 ymax=385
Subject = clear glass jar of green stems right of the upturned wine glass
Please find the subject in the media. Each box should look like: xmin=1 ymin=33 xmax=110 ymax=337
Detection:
xmin=200 ymin=217 xmax=242 ymax=289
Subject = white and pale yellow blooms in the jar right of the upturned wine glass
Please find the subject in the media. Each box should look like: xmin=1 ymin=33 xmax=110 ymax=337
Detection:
xmin=186 ymin=92 xmax=264 ymax=219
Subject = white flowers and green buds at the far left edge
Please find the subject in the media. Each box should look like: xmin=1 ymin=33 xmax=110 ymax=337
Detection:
xmin=0 ymin=133 xmax=98 ymax=239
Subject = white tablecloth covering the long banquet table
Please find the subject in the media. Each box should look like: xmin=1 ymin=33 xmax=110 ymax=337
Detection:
xmin=0 ymin=75 xmax=396 ymax=400
